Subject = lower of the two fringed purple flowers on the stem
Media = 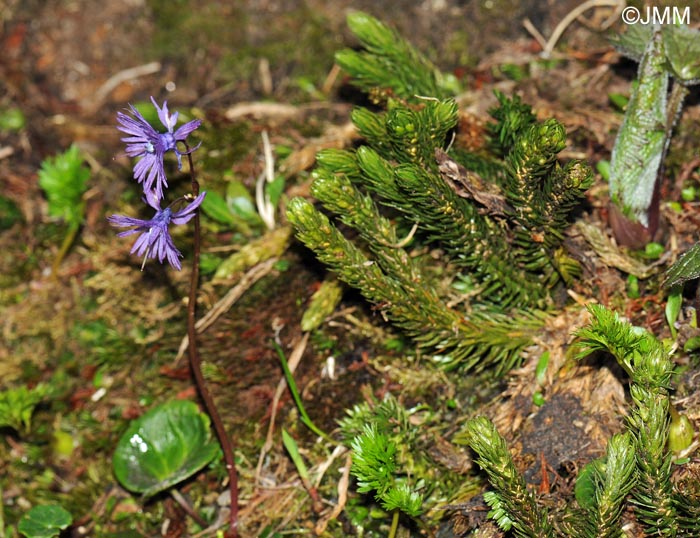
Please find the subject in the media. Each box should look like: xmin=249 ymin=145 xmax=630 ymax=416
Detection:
xmin=107 ymin=191 xmax=207 ymax=271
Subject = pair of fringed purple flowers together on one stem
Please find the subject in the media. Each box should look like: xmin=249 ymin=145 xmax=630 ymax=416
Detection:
xmin=107 ymin=97 xmax=206 ymax=270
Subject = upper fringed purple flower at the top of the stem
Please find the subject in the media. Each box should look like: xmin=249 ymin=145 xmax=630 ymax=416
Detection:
xmin=117 ymin=97 xmax=202 ymax=200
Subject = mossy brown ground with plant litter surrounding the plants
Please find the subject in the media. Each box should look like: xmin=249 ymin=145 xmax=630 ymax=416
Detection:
xmin=0 ymin=0 xmax=700 ymax=537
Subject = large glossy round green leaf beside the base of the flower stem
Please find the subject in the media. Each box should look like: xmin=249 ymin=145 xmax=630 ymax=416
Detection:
xmin=112 ymin=400 xmax=219 ymax=497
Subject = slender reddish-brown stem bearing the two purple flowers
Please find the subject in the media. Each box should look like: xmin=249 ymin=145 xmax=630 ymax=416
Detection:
xmin=185 ymin=143 xmax=238 ymax=538
